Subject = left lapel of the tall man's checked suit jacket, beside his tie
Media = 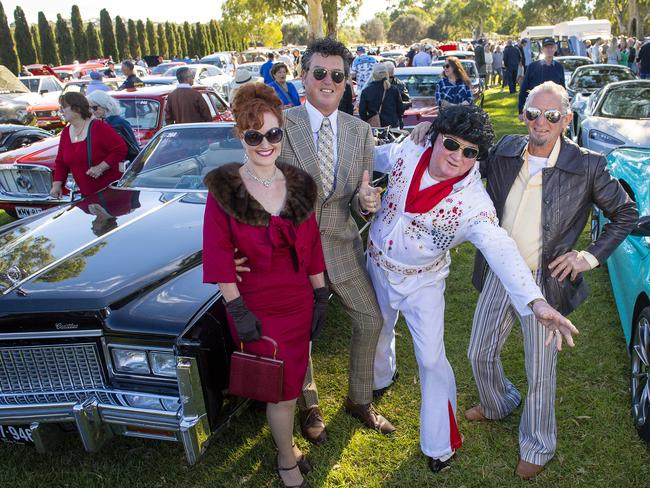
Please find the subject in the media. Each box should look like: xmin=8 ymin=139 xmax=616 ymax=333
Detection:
xmin=285 ymin=105 xmax=324 ymax=199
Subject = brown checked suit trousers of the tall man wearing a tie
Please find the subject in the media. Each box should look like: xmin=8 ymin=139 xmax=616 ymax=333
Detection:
xmin=298 ymin=268 xmax=382 ymax=410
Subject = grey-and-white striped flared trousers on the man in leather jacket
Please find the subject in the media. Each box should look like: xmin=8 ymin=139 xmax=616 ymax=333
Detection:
xmin=467 ymin=269 xmax=557 ymax=465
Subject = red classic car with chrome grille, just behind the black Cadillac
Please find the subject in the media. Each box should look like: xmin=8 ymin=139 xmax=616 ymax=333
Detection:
xmin=0 ymin=85 xmax=233 ymax=218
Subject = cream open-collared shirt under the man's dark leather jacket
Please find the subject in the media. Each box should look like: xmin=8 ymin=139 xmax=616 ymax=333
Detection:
xmin=501 ymin=137 xmax=598 ymax=271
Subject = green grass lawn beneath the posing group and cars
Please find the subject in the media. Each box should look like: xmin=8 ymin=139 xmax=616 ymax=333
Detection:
xmin=0 ymin=91 xmax=650 ymax=488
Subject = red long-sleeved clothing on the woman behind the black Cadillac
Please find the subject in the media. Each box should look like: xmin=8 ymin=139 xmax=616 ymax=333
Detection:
xmin=52 ymin=120 xmax=127 ymax=196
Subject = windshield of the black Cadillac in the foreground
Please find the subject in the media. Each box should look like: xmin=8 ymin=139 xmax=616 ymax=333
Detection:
xmin=119 ymin=124 xmax=244 ymax=190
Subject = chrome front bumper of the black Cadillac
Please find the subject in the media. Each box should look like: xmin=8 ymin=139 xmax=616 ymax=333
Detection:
xmin=0 ymin=356 xmax=210 ymax=464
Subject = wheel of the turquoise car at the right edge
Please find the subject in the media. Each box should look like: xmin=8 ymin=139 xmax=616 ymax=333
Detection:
xmin=630 ymin=307 xmax=650 ymax=443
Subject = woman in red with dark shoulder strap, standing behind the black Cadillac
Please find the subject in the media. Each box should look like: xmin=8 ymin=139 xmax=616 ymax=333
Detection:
xmin=50 ymin=92 xmax=127 ymax=198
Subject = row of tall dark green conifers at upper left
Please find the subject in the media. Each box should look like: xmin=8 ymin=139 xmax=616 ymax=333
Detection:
xmin=0 ymin=2 xmax=247 ymax=73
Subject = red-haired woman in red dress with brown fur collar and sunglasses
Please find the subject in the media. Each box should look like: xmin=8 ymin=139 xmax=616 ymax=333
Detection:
xmin=203 ymin=83 xmax=328 ymax=487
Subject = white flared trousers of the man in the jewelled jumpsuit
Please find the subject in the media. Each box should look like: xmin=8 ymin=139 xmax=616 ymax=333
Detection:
xmin=368 ymin=257 xmax=461 ymax=460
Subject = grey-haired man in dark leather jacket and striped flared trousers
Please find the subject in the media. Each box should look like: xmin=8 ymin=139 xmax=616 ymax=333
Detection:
xmin=465 ymin=81 xmax=638 ymax=479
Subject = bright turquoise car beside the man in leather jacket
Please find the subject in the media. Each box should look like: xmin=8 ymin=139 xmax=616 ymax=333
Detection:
xmin=592 ymin=148 xmax=650 ymax=443
